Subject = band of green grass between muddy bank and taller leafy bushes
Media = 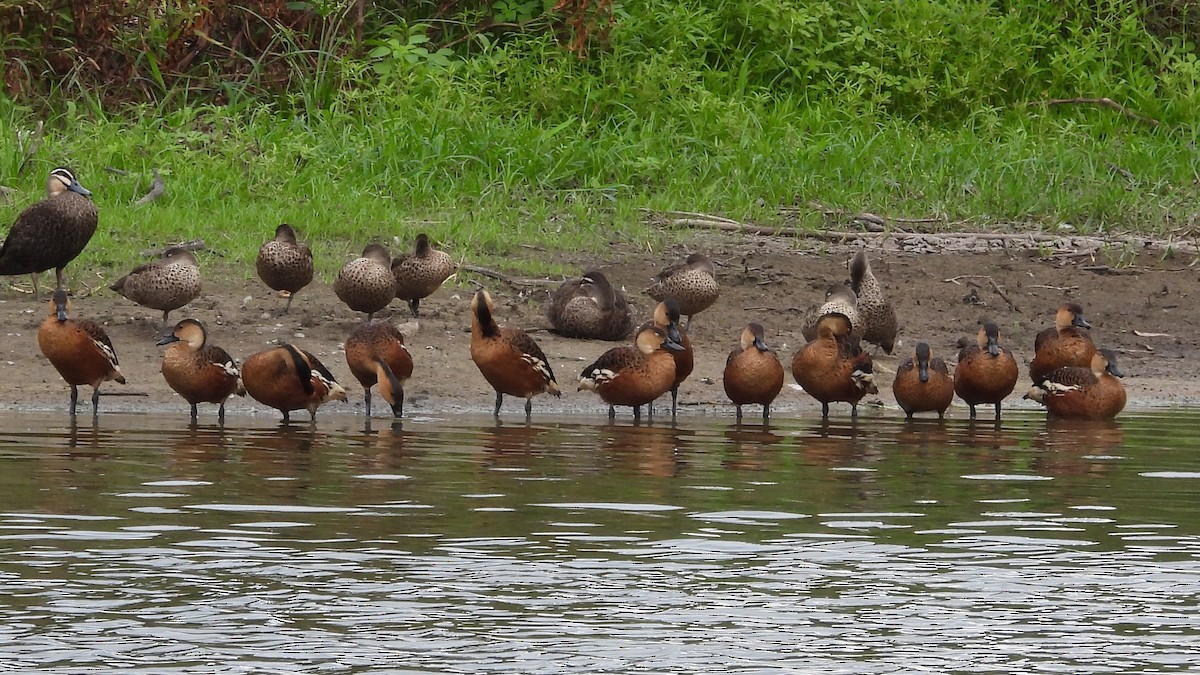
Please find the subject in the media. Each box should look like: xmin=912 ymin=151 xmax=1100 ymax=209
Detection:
xmin=0 ymin=86 xmax=1200 ymax=277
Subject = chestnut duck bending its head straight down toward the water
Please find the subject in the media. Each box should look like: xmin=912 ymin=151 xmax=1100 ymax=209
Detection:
xmin=346 ymin=321 xmax=413 ymax=417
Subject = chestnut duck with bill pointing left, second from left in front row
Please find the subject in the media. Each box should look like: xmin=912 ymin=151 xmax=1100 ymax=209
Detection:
xmin=158 ymin=318 xmax=246 ymax=422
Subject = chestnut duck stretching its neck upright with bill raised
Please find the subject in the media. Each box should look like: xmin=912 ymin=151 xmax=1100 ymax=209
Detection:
xmin=470 ymin=291 xmax=563 ymax=419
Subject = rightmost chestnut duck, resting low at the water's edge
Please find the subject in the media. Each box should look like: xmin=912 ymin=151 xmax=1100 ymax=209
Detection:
xmin=1025 ymin=350 xmax=1126 ymax=419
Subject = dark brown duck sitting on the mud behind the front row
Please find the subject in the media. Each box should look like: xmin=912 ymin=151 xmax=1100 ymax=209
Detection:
xmin=546 ymin=270 xmax=634 ymax=340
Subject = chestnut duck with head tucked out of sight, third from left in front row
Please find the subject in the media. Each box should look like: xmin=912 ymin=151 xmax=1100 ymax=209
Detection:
xmin=241 ymin=344 xmax=346 ymax=422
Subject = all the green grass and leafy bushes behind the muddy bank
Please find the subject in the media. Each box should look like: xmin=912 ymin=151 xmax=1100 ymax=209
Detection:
xmin=0 ymin=0 xmax=1200 ymax=273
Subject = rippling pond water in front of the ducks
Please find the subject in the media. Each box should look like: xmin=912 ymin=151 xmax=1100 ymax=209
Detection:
xmin=0 ymin=411 xmax=1200 ymax=674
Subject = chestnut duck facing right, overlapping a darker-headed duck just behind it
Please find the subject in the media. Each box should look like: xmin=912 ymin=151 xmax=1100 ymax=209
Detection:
xmin=580 ymin=325 xmax=683 ymax=420
